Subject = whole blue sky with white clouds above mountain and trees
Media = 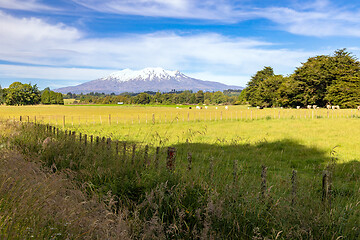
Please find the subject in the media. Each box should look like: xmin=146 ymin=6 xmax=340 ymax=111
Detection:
xmin=0 ymin=0 xmax=360 ymax=89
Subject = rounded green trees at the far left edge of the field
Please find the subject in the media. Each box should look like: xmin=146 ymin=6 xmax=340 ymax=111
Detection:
xmin=0 ymin=82 xmax=64 ymax=106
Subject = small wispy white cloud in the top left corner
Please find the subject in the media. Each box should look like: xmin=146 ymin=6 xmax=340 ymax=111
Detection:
xmin=0 ymin=0 xmax=55 ymax=11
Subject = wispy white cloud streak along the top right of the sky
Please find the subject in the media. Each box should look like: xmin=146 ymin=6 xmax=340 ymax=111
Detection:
xmin=69 ymin=0 xmax=360 ymax=37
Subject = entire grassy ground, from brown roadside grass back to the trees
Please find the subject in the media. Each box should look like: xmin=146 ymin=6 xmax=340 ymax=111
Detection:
xmin=0 ymin=106 xmax=360 ymax=239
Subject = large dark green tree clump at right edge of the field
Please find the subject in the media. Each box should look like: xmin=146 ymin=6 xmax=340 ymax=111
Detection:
xmin=240 ymin=49 xmax=360 ymax=108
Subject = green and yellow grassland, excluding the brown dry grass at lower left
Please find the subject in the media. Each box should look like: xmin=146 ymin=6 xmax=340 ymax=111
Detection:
xmin=0 ymin=106 xmax=360 ymax=239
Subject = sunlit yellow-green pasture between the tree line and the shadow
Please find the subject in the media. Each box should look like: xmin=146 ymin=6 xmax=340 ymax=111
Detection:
xmin=0 ymin=105 xmax=360 ymax=162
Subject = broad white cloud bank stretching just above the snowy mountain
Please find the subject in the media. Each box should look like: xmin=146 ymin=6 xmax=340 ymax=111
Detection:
xmin=0 ymin=12 xmax=320 ymax=86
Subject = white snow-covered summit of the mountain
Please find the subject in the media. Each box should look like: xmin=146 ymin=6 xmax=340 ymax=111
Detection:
xmin=100 ymin=67 xmax=188 ymax=82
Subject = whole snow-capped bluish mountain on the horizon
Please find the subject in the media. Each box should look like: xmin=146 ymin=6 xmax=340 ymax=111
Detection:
xmin=55 ymin=68 xmax=242 ymax=94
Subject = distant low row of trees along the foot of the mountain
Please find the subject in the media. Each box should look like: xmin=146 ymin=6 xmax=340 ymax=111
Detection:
xmin=74 ymin=90 xmax=240 ymax=105
